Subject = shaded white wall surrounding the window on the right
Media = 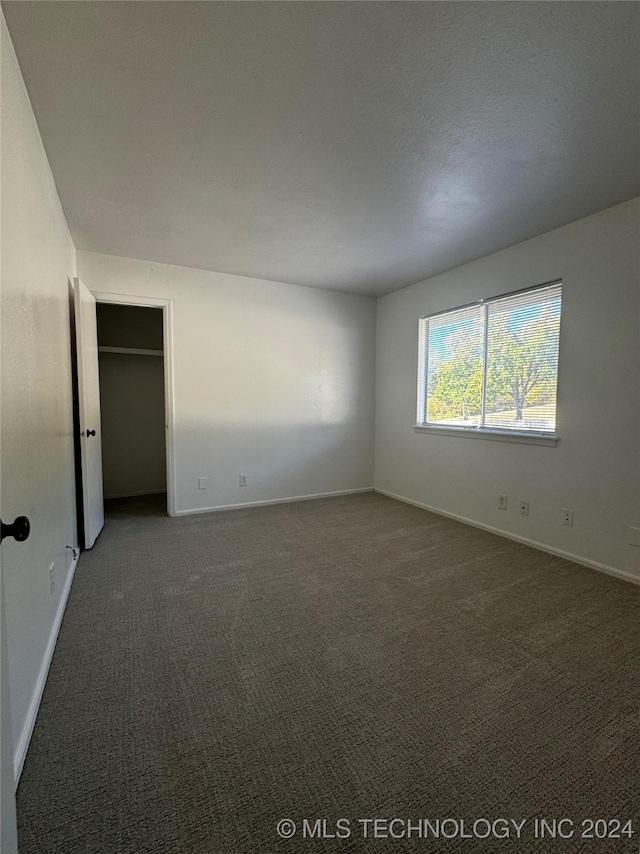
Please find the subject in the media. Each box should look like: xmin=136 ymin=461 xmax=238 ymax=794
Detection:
xmin=375 ymin=200 xmax=640 ymax=578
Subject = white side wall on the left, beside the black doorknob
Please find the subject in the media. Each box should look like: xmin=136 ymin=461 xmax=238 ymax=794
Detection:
xmin=1 ymin=11 xmax=77 ymax=776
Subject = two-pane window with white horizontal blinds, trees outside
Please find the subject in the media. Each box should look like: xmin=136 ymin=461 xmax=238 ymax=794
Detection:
xmin=418 ymin=282 xmax=562 ymax=435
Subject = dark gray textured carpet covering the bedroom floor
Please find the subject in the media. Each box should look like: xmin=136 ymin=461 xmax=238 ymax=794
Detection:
xmin=18 ymin=494 xmax=640 ymax=854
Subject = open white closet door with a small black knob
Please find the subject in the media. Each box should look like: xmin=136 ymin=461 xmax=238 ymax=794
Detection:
xmin=73 ymin=279 xmax=104 ymax=549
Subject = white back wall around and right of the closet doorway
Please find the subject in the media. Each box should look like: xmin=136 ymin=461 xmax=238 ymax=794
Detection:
xmin=78 ymin=252 xmax=376 ymax=513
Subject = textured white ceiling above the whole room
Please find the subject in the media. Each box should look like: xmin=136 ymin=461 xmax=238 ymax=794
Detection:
xmin=3 ymin=2 xmax=640 ymax=295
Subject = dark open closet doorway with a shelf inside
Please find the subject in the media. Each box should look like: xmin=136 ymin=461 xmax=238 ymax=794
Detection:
xmin=95 ymin=294 xmax=174 ymax=515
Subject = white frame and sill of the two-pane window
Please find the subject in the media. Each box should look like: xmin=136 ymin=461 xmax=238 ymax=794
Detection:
xmin=414 ymin=279 xmax=563 ymax=446
